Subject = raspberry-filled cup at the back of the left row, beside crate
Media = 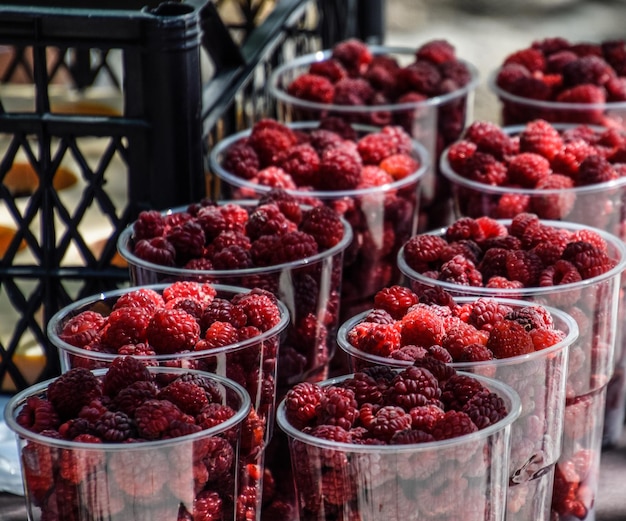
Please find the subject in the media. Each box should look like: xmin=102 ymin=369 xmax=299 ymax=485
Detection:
xmin=269 ymin=39 xmax=479 ymax=229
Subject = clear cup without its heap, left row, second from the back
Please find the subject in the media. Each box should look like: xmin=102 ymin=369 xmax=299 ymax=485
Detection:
xmin=210 ymin=122 xmax=429 ymax=317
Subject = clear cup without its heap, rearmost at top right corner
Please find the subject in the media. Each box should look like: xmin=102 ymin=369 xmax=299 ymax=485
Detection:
xmin=488 ymin=69 xmax=626 ymax=129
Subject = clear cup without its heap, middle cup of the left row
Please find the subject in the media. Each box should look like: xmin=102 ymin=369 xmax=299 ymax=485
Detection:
xmin=117 ymin=200 xmax=352 ymax=387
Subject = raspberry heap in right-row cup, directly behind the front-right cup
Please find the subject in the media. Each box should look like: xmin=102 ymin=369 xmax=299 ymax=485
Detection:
xmin=346 ymin=286 xmax=565 ymax=363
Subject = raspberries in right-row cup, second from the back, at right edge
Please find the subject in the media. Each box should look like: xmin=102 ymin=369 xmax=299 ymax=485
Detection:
xmin=444 ymin=119 xmax=626 ymax=222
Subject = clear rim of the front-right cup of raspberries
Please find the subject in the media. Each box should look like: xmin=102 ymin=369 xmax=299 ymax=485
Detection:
xmin=276 ymin=368 xmax=522 ymax=453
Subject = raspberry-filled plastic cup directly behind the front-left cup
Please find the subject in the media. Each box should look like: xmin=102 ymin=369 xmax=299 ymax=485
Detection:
xmin=48 ymin=281 xmax=289 ymax=521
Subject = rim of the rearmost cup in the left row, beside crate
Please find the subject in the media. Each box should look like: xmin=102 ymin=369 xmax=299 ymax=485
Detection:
xmin=268 ymin=45 xmax=480 ymax=114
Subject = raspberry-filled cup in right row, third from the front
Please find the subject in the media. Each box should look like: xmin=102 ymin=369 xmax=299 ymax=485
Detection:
xmin=398 ymin=213 xmax=626 ymax=520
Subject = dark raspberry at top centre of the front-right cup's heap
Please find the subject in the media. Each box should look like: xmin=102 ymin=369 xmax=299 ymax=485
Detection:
xmin=387 ymin=366 xmax=441 ymax=412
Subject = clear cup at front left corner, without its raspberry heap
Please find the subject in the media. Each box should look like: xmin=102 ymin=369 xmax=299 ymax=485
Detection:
xmin=4 ymin=367 xmax=251 ymax=521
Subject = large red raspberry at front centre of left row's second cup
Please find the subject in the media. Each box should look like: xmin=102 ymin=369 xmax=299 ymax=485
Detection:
xmin=146 ymin=308 xmax=200 ymax=354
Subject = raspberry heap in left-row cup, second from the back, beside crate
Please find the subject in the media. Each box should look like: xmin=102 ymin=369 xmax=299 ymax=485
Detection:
xmin=221 ymin=118 xmax=422 ymax=192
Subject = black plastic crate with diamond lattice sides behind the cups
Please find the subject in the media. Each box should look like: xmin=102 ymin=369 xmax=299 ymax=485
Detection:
xmin=0 ymin=0 xmax=382 ymax=391
